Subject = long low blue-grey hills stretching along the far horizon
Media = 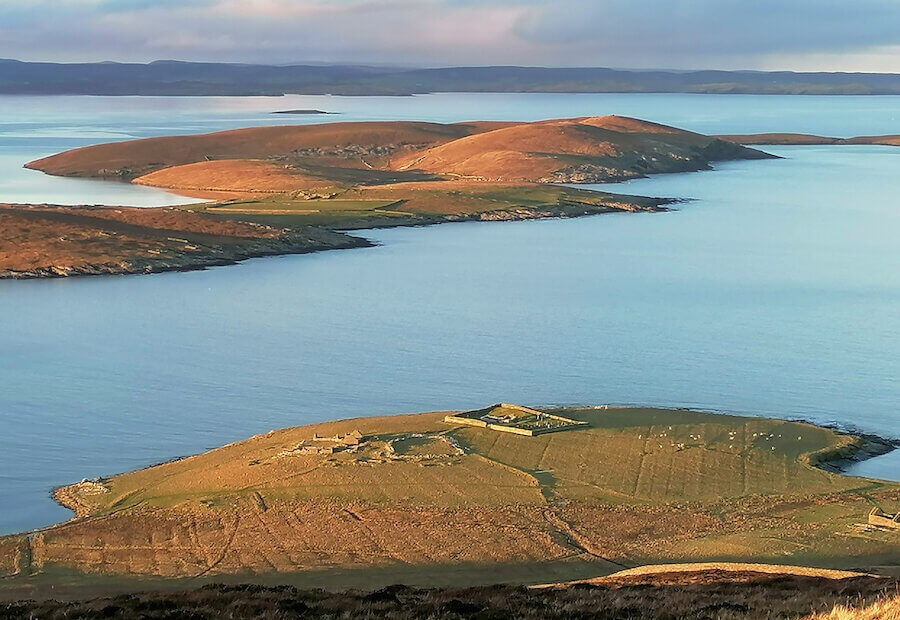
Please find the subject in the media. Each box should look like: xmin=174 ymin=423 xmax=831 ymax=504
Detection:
xmin=0 ymin=60 xmax=900 ymax=96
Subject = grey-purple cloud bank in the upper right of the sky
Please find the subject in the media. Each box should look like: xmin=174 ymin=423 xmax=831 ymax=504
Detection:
xmin=516 ymin=0 xmax=900 ymax=57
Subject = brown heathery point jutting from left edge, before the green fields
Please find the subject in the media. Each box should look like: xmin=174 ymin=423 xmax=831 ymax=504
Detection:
xmin=0 ymin=205 xmax=362 ymax=277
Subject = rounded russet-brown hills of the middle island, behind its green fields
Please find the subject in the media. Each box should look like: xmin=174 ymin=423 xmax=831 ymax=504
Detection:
xmin=29 ymin=116 xmax=765 ymax=192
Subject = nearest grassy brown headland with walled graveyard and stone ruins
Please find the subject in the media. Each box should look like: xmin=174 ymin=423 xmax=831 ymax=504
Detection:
xmin=0 ymin=404 xmax=900 ymax=617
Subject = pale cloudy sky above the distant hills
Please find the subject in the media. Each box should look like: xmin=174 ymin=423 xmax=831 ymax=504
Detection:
xmin=0 ymin=0 xmax=900 ymax=73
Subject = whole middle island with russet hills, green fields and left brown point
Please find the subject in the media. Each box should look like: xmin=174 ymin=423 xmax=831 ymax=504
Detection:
xmin=0 ymin=116 xmax=770 ymax=278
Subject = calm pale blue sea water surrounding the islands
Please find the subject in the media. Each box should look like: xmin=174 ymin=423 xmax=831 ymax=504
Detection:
xmin=0 ymin=95 xmax=900 ymax=532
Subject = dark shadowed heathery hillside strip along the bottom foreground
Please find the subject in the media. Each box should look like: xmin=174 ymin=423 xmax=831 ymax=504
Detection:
xmin=0 ymin=571 xmax=900 ymax=620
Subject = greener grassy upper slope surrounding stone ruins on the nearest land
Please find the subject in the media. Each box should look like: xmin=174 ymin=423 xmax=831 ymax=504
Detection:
xmin=61 ymin=409 xmax=870 ymax=513
